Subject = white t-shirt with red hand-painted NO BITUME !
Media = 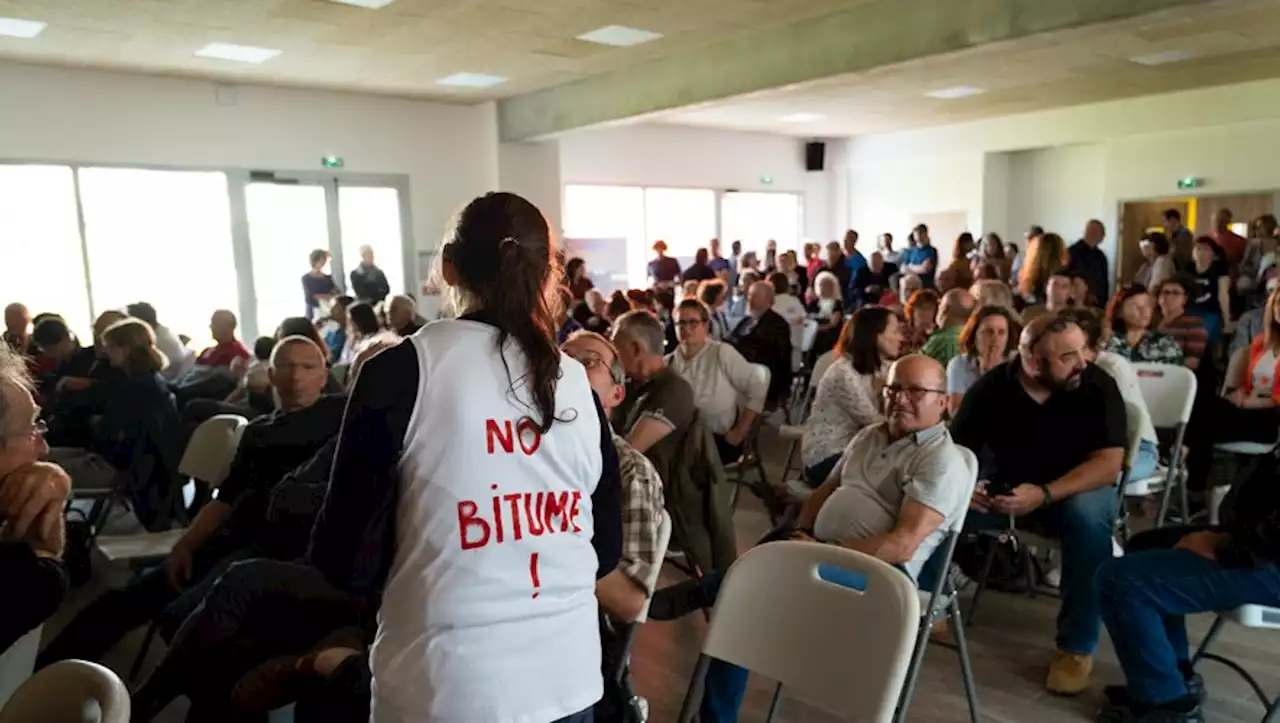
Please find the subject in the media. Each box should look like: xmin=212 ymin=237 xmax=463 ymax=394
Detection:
xmin=370 ymin=320 xmax=603 ymax=723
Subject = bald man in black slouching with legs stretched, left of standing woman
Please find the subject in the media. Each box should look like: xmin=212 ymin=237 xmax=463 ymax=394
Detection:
xmin=37 ymin=337 xmax=346 ymax=667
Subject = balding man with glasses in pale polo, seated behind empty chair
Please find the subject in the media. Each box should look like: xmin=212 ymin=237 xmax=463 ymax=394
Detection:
xmin=649 ymin=354 xmax=973 ymax=723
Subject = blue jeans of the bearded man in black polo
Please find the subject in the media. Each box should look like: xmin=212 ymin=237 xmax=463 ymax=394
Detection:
xmin=965 ymin=485 xmax=1119 ymax=655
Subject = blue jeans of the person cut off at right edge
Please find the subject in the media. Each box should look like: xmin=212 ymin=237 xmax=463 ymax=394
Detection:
xmin=1096 ymin=527 xmax=1280 ymax=706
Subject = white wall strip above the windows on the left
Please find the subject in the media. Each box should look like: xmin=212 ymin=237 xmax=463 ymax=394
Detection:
xmin=0 ymin=63 xmax=498 ymax=259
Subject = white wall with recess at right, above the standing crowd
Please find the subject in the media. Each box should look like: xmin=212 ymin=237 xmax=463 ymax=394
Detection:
xmin=846 ymin=79 xmax=1280 ymax=273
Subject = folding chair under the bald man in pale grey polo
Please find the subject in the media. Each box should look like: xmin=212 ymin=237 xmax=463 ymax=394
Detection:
xmin=893 ymin=447 xmax=980 ymax=723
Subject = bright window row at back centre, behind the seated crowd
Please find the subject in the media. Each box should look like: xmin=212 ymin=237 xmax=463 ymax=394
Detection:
xmin=564 ymin=184 xmax=803 ymax=289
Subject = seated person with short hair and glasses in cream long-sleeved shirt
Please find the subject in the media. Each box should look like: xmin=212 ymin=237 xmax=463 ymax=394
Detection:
xmin=667 ymin=299 xmax=769 ymax=465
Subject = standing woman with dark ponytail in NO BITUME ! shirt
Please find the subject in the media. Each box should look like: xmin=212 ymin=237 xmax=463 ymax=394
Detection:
xmin=311 ymin=193 xmax=621 ymax=723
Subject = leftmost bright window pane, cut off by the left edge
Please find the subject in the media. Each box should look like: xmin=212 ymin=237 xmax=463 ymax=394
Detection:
xmin=0 ymin=165 xmax=92 ymax=343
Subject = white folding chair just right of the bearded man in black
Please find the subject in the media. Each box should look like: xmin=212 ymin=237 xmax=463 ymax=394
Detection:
xmin=1124 ymin=362 xmax=1196 ymax=527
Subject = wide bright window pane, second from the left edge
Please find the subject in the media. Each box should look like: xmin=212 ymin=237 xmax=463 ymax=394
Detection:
xmin=79 ymin=168 xmax=239 ymax=349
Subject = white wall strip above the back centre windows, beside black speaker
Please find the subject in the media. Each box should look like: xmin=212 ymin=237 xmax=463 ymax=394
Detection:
xmin=559 ymin=124 xmax=845 ymax=245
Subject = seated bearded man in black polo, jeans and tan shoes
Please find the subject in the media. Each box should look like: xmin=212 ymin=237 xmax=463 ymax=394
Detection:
xmin=951 ymin=314 xmax=1126 ymax=695
